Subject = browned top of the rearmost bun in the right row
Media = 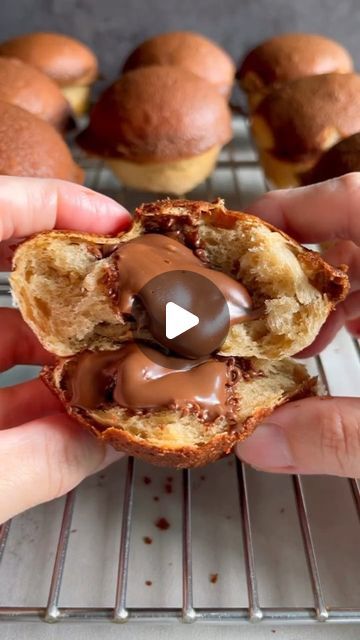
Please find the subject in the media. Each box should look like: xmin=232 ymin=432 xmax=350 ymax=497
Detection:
xmin=237 ymin=33 xmax=353 ymax=111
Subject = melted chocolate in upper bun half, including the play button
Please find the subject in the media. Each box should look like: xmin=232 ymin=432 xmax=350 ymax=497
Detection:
xmin=111 ymin=234 xmax=251 ymax=358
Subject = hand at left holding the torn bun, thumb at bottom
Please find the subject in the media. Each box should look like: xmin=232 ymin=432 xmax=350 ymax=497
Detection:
xmin=0 ymin=176 xmax=130 ymax=522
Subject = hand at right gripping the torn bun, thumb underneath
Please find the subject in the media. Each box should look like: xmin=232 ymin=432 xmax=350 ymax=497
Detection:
xmin=236 ymin=173 xmax=360 ymax=477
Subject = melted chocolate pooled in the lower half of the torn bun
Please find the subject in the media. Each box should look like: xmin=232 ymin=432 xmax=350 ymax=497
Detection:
xmin=67 ymin=342 xmax=241 ymax=422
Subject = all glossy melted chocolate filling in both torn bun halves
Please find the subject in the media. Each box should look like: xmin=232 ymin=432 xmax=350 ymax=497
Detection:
xmin=70 ymin=234 xmax=254 ymax=422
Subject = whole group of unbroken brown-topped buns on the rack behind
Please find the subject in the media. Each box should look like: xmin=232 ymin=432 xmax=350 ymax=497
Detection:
xmin=0 ymin=26 xmax=360 ymax=190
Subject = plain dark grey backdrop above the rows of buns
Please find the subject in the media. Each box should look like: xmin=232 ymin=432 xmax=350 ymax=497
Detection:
xmin=0 ymin=0 xmax=360 ymax=77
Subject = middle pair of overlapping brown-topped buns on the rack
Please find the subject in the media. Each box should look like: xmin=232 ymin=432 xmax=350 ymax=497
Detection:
xmin=78 ymin=32 xmax=235 ymax=195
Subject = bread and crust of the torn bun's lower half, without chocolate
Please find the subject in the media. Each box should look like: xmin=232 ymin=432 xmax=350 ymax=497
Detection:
xmin=43 ymin=358 xmax=316 ymax=467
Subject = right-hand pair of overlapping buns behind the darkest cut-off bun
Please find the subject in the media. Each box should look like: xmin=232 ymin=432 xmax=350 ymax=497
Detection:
xmin=237 ymin=33 xmax=360 ymax=188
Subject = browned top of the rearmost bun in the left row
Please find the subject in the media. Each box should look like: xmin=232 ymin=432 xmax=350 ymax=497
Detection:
xmin=0 ymin=32 xmax=98 ymax=85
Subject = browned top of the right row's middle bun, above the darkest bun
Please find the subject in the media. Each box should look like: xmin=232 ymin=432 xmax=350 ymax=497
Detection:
xmin=253 ymin=73 xmax=360 ymax=158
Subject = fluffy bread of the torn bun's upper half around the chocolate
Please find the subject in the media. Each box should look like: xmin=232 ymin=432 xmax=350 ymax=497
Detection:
xmin=11 ymin=200 xmax=348 ymax=360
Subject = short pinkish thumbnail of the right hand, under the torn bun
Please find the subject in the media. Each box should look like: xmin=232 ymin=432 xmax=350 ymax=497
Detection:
xmin=236 ymin=423 xmax=294 ymax=469
